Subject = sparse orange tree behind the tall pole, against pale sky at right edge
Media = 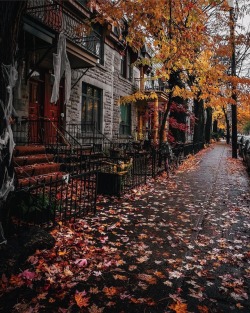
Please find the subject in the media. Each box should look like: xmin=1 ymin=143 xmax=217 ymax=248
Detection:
xmin=202 ymin=1 xmax=250 ymax=143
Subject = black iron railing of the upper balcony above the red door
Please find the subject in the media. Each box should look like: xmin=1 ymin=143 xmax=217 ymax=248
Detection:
xmin=27 ymin=0 xmax=101 ymax=58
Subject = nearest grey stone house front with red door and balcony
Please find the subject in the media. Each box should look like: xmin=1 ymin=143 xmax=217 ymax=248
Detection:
xmin=14 ymin=1 xmax=140 ymax=145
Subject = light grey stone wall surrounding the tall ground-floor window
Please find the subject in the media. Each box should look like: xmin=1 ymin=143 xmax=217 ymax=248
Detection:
xmin=66 ymin=44 xmax=140 ymax=139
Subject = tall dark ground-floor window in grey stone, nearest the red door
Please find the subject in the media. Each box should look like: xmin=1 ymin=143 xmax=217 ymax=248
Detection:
xmin=82 ymin=83 xmax=102 ymax=130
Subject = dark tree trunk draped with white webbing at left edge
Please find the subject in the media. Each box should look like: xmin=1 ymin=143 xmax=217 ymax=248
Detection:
xmin=0 ymin=1 xmax=26 ymax=244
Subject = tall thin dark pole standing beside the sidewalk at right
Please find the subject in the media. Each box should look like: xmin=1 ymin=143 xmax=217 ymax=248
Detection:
xmin=227 ymin=0 xmax=237 ymax=159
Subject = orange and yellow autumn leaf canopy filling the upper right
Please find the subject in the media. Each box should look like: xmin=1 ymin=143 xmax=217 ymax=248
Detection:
xmin=91 ymin=0 xmax=250 ymax=136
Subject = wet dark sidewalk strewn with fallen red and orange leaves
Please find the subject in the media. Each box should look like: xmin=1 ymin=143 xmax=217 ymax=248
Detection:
xmin=0 ymin=143 xmax=250 ymax=313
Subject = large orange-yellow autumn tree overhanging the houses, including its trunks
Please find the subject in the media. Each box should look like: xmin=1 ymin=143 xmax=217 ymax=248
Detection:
xmin=91 ymin=0 xmax=250 ymax=141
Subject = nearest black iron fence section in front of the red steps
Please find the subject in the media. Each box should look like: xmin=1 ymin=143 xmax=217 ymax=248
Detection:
xmin=9 ymin=172 xmax=96 ymax=227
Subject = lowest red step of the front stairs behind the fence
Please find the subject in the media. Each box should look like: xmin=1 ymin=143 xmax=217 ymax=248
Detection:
xmin=18 ymin=171 xmax=67 ymax=188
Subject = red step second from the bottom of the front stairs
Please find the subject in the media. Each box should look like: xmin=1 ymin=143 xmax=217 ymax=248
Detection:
xmin=15 ymin=162 xmax=61 ymax=179
